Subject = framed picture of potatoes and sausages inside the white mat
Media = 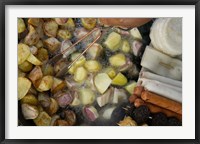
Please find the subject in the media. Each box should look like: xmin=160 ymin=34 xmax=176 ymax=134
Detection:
xmin=17 ymin=18 xmax=182 ymax=126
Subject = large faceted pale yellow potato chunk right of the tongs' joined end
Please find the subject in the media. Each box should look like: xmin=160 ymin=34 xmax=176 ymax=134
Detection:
xmin=104 ymin=32 xmax=121 ymax=51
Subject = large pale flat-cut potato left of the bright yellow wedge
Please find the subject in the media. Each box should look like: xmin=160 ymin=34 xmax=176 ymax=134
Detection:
xmin=94 ymin=73 xmax=112 ymax=94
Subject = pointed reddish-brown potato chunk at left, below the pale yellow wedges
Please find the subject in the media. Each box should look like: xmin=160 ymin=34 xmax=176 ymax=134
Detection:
xmin=28 ymin=66 xmax=43 ymax=84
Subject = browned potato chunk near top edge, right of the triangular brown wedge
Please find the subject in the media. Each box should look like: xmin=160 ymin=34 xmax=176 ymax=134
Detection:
xmin=43 ymin=20 xmax=58 ymax=37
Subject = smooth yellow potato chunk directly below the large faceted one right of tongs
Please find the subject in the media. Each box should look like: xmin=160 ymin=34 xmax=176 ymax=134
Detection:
xmin=109 ymin=53 xmax=126 ymax=67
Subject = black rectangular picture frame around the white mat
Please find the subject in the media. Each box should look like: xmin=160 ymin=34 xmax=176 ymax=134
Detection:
xmin=0 ymin=0 xmax=200 ymax=144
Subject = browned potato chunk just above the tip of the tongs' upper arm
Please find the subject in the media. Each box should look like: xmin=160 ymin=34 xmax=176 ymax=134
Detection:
xmin=44 ymin=37 xmax=61 ymax=53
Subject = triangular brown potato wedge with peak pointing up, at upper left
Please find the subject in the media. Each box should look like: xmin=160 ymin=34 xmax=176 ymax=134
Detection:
xmin=24 ymin=25 xmax=40 ymax=45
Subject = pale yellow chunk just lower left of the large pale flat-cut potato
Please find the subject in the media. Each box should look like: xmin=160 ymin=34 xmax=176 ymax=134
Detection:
xmin=79 ymin=88 xmax=95 ymax=105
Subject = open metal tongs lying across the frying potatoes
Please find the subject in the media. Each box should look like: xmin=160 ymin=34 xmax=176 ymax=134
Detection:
xmin=49 ymin=28 xmax=102 ymax=77
